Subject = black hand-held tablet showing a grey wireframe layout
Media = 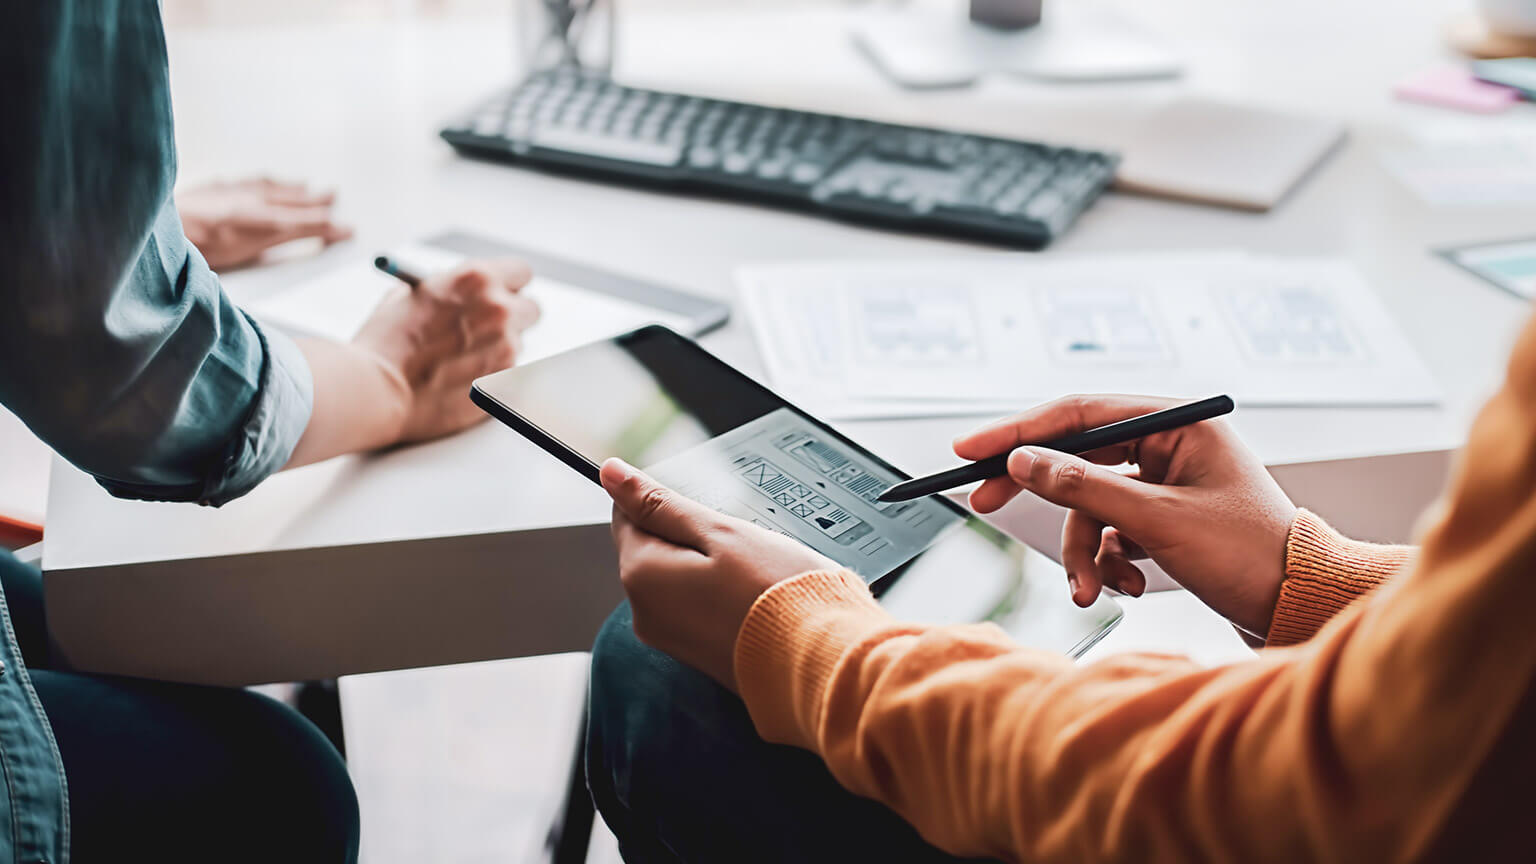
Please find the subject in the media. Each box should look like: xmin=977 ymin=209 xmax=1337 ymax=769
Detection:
xmin=472 ymin=326 xmax=1120 ymax=655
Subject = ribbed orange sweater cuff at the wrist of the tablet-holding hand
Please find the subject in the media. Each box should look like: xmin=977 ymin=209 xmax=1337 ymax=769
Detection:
xmin=734 ymin=570 xmax=891 ymax=749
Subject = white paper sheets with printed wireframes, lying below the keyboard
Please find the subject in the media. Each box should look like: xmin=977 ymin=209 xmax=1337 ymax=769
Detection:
xmin=739 ymin=252 xmax=1439 ymax=417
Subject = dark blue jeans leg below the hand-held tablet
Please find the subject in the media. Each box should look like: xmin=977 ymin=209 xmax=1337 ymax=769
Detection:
xmin=587 ymin=604 xmax=983 ymax=864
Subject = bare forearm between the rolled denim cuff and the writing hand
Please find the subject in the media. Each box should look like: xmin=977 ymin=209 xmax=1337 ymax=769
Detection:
xmin=287 ymin=338 xmax=410 ymax=467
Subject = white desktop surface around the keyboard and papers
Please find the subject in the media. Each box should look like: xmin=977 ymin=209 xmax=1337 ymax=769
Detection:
xmin=36 ymin=0 xmax=1536 ymax=682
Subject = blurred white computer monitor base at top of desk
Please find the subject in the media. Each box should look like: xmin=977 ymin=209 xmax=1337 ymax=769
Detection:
xmin=849 ymin=0 xmax=1181 ymax=89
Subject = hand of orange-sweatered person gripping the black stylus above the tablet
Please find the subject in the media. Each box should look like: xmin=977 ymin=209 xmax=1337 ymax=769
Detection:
xmin=955 ymin=395 xmax=1296 ymax=638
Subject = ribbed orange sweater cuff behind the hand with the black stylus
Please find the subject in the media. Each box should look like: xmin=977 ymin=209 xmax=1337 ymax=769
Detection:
xmin=1266 ymin=510 xmax=1413 ymax=646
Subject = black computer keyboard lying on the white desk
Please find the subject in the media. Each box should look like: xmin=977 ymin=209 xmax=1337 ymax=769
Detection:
xmin=442 ymin=71 xmax=1118 ymax=249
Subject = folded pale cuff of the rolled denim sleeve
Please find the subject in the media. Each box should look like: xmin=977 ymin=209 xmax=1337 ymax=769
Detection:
xmin=200 ymin=320 xmax=315 ymax=507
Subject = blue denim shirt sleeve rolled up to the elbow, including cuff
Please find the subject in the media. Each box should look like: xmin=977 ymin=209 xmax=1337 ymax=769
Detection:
xmin=0 ymin=0 xmax=313 ymax=504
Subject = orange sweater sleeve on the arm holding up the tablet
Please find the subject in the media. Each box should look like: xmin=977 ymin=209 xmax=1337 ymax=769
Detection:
xmin=736 ymin=315 xmax=1536 ymax=862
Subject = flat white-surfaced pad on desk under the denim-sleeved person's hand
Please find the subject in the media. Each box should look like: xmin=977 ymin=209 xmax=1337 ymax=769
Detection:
xmin=247 ymin=232 xmax=731 ymax=356
